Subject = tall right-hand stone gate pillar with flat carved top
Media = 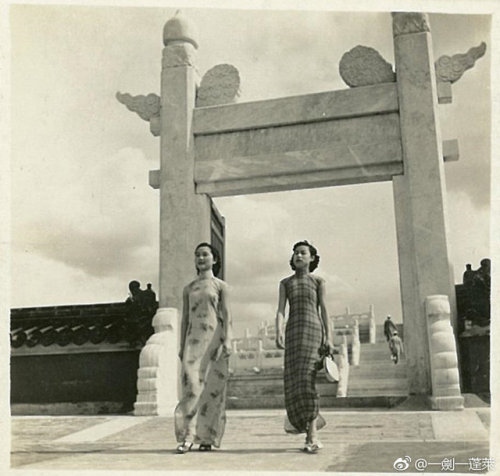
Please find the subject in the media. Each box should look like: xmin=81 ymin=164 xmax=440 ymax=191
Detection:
xmin=393 ymin=13 xmax=455 ymax=395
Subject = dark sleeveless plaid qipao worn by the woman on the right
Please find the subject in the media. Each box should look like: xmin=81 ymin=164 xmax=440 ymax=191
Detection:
xmin=282 ymin=274 xmax=325 ymax=433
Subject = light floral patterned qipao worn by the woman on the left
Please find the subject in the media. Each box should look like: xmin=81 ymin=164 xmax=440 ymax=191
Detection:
xmin=175 ymin=277 xmax=229 ymax=448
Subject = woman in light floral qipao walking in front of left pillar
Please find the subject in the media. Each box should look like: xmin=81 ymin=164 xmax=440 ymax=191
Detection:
xmin=174 ymin=243 xmax=231 ymax=454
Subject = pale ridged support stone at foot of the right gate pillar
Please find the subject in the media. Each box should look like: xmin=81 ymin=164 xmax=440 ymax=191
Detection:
xmin=425 ymin=295 xmax=464 ymax=410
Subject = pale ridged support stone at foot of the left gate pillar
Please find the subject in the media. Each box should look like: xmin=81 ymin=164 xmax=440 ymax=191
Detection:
xmin=134 ymin=308 xmax=178 ymax=416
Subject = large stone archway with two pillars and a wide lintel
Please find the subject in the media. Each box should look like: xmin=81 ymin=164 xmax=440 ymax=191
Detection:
xmin=117 ymin=13 xmax=484 ymax=411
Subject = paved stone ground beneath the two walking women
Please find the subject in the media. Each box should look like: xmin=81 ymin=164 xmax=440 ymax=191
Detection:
xmin=6 ymin=407 xmax=492 ymax=474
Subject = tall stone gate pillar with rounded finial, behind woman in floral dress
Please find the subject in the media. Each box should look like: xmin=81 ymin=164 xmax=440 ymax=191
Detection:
xmin=137 ymin=14 xmax=210 ymax=415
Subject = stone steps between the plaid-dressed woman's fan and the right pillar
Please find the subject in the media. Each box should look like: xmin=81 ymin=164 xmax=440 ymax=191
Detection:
xmin=347 ymin=341 xmax=408 ymax=398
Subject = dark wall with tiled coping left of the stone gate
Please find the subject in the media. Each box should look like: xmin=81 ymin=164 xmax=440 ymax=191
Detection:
xmin=10 ymin=303 xmax=154 ymax=414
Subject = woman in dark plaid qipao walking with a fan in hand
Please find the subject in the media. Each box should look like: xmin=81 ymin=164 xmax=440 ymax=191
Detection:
xmin=276 ymin=241 xmax=333 ymax=453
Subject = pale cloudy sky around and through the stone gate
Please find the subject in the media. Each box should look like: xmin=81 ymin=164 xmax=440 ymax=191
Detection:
xmin=3 ymin=2 xmax=491 ymax=335
